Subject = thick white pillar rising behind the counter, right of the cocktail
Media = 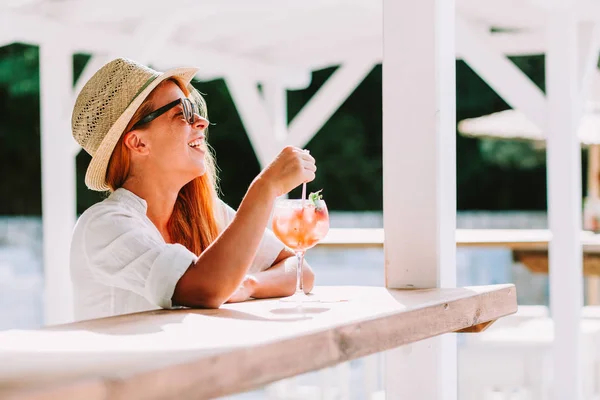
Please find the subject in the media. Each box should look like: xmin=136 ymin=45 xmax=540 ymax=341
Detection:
xmin=383 ymin=0 xmax=457 ymax=400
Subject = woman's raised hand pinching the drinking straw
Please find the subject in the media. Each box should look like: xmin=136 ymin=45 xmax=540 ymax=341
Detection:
xmin=256 ymin=146 xmax=317 ymax=197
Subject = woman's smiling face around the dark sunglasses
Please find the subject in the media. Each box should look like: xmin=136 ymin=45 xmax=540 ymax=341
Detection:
xmin=131 ymin=81 xmax=208 ymax=184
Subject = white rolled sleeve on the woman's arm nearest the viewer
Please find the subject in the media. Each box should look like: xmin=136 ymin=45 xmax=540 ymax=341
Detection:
xmin=83 ymin=208 xmax=198 ymax=308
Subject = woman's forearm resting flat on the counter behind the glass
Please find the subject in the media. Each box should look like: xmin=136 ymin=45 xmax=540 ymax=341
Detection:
xmin=251 ymin=256 xmax=314 ymax=299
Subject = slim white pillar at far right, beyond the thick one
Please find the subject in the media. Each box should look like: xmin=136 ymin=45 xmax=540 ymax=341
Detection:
xmin=546 ymin=0 xmax=583 ymax=400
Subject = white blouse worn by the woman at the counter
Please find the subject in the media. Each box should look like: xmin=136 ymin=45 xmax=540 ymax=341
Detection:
xmin=70 ymin=188 xmax=284 ymax=320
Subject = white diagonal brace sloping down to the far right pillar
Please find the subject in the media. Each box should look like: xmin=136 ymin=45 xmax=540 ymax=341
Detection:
xmin=456 ymin=18 xmax=546 ymax=127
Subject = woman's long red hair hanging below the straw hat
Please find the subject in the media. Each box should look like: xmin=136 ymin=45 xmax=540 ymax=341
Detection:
xmin=106 ymin=78 xmax=219 ymax=255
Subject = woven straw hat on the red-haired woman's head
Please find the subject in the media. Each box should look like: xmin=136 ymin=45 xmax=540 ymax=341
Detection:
xmin=71 ymin=58 xmax=198 ymax=191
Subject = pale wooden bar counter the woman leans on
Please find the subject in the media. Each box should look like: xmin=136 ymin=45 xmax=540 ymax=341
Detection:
xmin=0 ymin=285 xmax=517 ymax=400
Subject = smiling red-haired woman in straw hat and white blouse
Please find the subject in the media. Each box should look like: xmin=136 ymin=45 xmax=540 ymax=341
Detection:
xmin=70 ymin=59 xmax=316 ymax=320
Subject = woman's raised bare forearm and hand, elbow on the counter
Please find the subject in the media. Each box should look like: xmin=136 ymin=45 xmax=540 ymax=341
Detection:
xmin=173 ymin=146 xmax=316 ymax=308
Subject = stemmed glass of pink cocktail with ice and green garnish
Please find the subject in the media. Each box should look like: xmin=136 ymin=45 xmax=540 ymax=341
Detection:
xmin=273 ymin=198 xmax=329 ymax=302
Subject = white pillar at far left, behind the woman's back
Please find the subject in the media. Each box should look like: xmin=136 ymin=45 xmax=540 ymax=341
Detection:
xmin=40 ymin=43 xmax=76 ymax=324
